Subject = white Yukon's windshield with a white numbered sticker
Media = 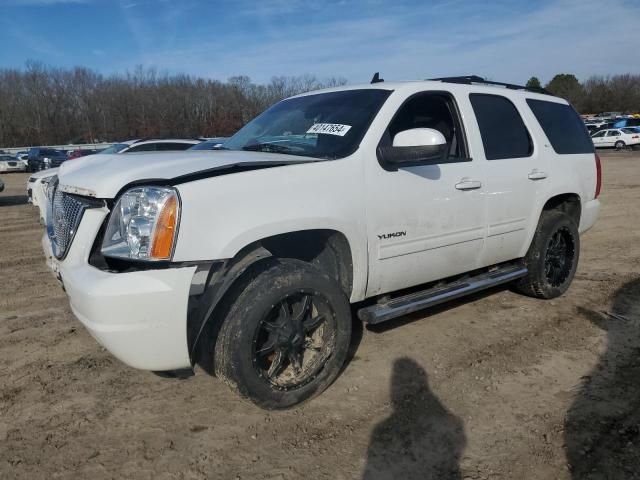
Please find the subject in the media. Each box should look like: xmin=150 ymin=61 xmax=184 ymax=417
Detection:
xmin=222 ymin=89 xmax=391 ymax=159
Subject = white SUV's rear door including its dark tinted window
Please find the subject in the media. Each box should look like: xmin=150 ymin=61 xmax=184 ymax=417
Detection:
xmin=469 ymin=92 xmax=549 ymax=266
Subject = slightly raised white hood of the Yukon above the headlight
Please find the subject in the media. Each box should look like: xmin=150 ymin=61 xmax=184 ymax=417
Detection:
xmin=58 ymin=150 xmax=319 ymax=198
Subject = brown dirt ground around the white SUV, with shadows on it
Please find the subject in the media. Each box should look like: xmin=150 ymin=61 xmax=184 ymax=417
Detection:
xmin=0 ymin=152 xmax=640 ymax=480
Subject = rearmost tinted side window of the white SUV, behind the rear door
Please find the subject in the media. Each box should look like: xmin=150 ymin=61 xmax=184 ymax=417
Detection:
xmin=527 ymin=98 xmax=593 ymax=155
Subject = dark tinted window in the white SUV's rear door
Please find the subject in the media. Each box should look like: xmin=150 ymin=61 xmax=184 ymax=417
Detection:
xmin=469 ymin=93 xmax=533 ymax=160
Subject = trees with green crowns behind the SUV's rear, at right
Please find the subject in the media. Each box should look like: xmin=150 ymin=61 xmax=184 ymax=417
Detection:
xmin=527 ymin=73 xmax=640 ymax=113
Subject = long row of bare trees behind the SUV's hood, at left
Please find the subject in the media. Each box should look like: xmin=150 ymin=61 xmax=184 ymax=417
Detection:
xmin=0 ymin=63 xmax=346 ymax=147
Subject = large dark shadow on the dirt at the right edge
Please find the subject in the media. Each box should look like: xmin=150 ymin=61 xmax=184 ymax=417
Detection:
xmin=565 ymin=279 xmax=640 ymax=480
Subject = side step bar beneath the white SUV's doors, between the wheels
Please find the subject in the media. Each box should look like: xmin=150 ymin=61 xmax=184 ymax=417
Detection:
xmin=358 ymin=264 xmax=527 ymax=325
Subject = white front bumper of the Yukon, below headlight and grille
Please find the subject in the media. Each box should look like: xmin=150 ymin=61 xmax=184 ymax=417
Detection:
xmin=42 ymin=208 xmax=196 ymax=371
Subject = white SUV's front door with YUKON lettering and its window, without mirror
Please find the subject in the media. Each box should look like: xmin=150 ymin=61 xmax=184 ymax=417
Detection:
xmin=366 ymin=91 xmax=485 ymax=296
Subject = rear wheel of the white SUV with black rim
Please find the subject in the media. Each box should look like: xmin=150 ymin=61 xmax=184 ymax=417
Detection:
xmin=515 ymin=210 xmax=580 ymax=298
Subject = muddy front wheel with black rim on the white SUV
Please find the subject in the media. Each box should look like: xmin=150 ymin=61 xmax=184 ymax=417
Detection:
xmin=214 ymin=259 xmax=351 ymax=409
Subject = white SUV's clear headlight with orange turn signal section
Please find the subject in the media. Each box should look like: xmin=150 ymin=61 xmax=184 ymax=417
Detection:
xmin=102 ymin=187 xmax=180 ymax=260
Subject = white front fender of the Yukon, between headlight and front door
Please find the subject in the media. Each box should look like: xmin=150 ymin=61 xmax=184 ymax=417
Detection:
xmin=174 ymin=158 xmax=367 ymax=301
